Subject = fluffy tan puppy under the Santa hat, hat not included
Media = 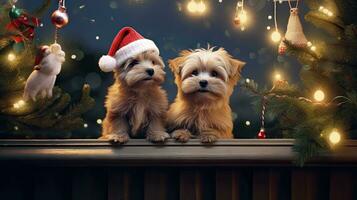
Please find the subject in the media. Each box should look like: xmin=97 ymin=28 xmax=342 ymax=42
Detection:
xmin=98 ymin=51 xmax=169 ymax=143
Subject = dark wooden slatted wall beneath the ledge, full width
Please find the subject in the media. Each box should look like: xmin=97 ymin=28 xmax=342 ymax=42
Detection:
xmin=0 ymin=166 xmax=357 ymax=200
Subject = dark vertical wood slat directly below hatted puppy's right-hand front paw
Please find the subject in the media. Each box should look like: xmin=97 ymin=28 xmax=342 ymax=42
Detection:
xmin=144 ymin=168 xmax=168 ymax=200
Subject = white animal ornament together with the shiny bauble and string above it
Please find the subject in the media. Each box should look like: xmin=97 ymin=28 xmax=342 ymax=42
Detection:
xmin=23 ymin=0 xmax=68 ymax=101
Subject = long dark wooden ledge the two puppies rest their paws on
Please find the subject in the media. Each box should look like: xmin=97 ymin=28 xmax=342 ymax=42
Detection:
xmin=0 ymin=139 xmax=357 ymax=166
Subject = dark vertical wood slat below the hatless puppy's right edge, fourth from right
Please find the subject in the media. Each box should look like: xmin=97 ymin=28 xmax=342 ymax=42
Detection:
xmin=216 ymin=169 xmax=239 ymax=200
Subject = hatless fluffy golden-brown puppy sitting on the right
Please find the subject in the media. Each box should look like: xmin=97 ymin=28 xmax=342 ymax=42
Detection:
xmin=167 ymin=48 xmax=245 ymax=143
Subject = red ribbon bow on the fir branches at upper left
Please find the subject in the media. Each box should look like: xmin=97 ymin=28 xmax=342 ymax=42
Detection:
xmin=6 ymin=14 xmax=40 ymax=43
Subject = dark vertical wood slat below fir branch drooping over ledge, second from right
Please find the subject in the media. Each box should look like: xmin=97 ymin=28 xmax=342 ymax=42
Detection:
xmin=291 ymin=169 xmax=319 ymax=200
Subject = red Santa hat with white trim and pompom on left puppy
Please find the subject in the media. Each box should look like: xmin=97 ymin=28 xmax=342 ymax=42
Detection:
xmin=99 ymin=27 xmax=159 ymax=72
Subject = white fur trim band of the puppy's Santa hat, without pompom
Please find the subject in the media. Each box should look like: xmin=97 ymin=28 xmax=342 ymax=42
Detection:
xmin=114 ymin=39 xmax=160 ymax=66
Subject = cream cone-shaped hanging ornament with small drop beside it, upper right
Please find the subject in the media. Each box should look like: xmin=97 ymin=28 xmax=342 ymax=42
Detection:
xmin=278 ymin=0 xmax=308 ymax=54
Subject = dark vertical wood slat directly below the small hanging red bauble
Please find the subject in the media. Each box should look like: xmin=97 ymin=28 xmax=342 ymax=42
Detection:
xmin=253 ymin=169 xmax=279 ymax=200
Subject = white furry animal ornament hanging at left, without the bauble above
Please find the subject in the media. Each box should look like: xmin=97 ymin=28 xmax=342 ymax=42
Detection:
xmin=23 ymin=43 xmax=65 ymax=101
